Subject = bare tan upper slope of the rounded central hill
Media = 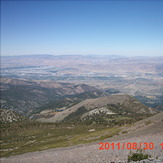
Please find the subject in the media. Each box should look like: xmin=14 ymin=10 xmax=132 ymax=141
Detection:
xmin=38 ymin=94 xmax=156 ymax=122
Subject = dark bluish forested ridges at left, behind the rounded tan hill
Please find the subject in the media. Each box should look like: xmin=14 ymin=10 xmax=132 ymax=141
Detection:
xmin=0 ymin=78 xmax=103 ymax=115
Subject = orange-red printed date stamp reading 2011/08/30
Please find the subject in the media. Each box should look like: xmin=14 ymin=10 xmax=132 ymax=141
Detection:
xmin=99 ymin=142 xmax=163 ymax=150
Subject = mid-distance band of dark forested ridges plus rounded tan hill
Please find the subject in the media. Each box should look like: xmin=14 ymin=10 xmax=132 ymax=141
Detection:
xmin=0 ymin=78 xmax=158 ymax=121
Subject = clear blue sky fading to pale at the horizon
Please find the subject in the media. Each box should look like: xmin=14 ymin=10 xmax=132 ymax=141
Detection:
xmin=1 ymin=0 xmax=163 ymax=56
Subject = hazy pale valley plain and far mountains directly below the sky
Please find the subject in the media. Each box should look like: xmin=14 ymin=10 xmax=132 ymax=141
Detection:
xmin=1 ymin=54 xmax=163 ymax=107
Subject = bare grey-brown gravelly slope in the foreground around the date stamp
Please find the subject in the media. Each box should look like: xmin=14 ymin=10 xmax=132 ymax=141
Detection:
xmin=0 ymin=113 xmax=163 ymax=163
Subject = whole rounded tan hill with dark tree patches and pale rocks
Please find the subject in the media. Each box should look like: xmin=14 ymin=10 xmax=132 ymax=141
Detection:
xmin=35 ymin=94 xmax=157 ymax=124
